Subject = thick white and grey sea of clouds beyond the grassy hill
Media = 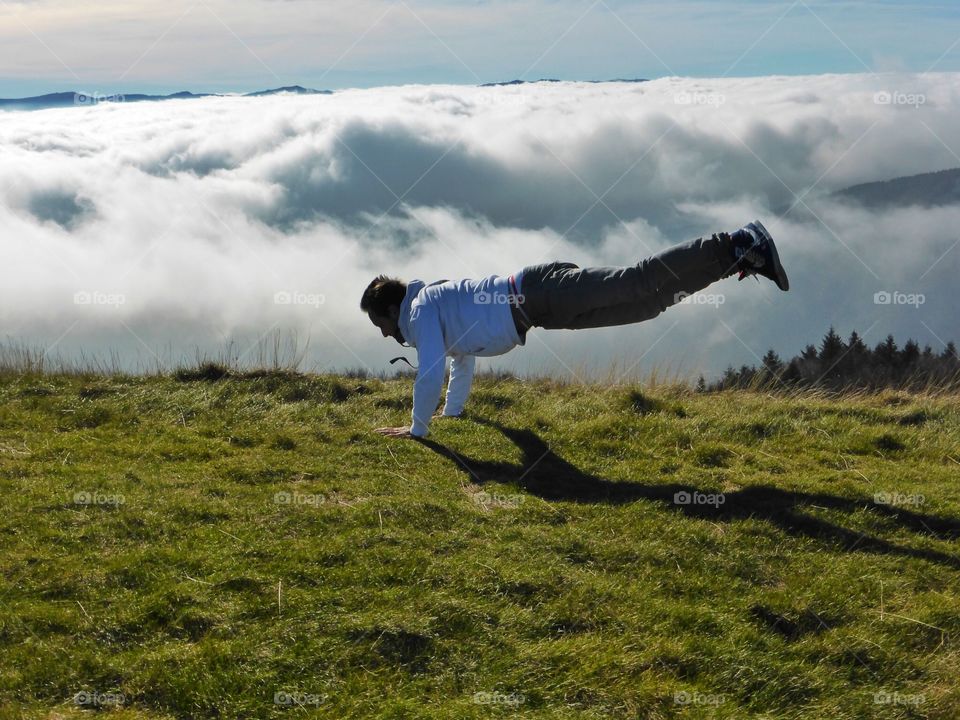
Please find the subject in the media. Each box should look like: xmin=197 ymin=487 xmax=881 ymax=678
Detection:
xmin=0 ymin=74 xmax=960 ymax=376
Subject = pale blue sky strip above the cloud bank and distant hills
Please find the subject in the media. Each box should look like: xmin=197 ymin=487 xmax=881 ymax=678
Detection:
xmin=0 ymin=0 xmax=960 ymax=97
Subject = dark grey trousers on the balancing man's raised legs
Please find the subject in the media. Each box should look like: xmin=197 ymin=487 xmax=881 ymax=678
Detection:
xmin=520 ymin=233 xmax=737 ymax=330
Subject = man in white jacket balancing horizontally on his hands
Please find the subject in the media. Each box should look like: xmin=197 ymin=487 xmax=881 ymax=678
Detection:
xmin=360 ymin=220 xmax=790 ymax=437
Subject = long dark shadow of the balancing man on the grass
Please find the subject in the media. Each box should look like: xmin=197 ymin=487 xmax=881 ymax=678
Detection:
xmin=419 ymin=415 xmax=960 ymax=569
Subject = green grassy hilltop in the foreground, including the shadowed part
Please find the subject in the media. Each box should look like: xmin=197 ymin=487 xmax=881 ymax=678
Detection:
xmin=0 ymin=371 xmax=960 ymax=719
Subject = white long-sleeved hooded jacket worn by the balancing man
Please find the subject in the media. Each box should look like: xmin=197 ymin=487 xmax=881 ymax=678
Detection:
xmin=399 ymin=273 xmax=526 ymax=437
